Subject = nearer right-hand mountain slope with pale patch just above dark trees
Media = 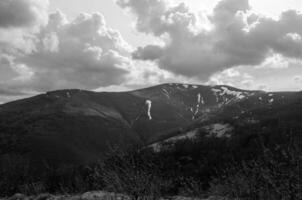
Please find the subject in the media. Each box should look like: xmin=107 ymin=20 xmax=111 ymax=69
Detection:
xmin=149 ymin=88 xmax=302 ymax=152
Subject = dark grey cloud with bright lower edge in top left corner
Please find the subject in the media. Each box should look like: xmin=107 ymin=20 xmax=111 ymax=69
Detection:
xmin=0 ymin=0 xmax=49 ymax=55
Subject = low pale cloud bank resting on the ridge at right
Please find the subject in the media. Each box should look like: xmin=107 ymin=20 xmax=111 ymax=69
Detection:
xmin=206 ymin=59 xmax=302 ymax=91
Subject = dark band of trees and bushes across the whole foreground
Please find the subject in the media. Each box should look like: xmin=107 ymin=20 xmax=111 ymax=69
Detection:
xmin=0 ymin=119 xmax=302 ymax=200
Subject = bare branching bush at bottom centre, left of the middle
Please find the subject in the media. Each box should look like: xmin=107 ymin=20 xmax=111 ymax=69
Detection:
xmin=103 ymin=146 xmax=171 ymax=199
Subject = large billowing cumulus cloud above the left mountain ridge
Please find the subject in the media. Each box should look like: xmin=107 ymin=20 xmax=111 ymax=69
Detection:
xmin=15 ymin=12 xmax=131 ymax=91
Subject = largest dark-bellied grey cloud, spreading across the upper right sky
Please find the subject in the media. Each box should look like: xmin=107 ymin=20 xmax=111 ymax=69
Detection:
xmin=118 ymin=0 xmax=302 ymax=81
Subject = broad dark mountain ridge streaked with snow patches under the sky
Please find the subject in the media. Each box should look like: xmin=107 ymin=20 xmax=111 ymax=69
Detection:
xmin=0 ymin=84 xmax=302 ymax=164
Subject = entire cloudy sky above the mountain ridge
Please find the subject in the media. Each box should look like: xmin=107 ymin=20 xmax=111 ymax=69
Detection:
xmin=0 ymin=0 xmax=302 ymax=103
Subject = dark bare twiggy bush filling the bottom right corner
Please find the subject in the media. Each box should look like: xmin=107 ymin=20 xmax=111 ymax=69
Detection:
xmin=210 ymin=132 xmax=302 ymax=200
